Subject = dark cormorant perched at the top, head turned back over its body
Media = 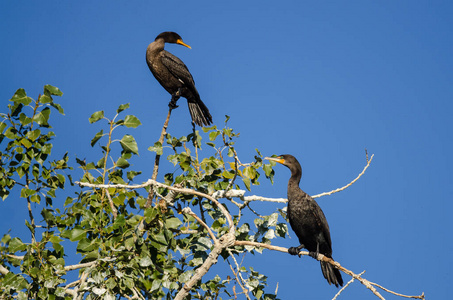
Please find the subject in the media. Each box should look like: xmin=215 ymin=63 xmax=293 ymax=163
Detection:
xmin=146 ymin=31 xmax=212 ymax=126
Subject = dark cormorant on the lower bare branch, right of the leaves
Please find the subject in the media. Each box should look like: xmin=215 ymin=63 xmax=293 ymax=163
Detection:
xmin=266 ymin=154 xmax=343 ymax=287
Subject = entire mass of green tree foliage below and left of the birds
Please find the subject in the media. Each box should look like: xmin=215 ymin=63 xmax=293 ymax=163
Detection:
xmin=0 ymin=86 xmax=287 ymax=299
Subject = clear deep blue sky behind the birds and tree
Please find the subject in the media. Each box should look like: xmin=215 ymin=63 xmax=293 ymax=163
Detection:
xmin=0 ymin=1 xmax=453 ymax=299
